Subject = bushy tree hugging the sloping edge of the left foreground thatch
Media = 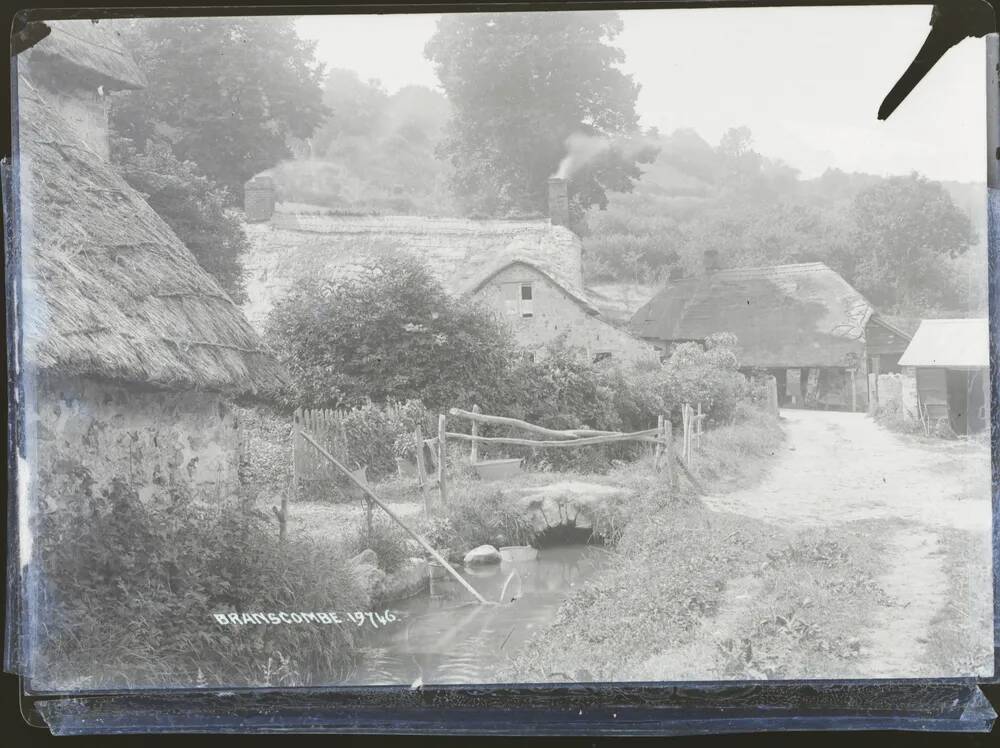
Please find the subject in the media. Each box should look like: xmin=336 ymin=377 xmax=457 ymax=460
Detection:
xmin=111 ymin=138 xmax=249 ymax=303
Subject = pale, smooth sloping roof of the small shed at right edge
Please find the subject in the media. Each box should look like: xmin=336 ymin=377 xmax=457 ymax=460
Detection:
xmin=899 ymin=319 xmax=990 ymax=369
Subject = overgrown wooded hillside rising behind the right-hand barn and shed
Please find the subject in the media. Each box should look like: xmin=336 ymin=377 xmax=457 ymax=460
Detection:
xmin=584 ymin=127 xmax=986 ymax=317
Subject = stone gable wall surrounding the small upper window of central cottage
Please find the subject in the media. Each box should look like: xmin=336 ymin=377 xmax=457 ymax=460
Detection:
xmin=476 ymin=265 xmax=656 ymax=360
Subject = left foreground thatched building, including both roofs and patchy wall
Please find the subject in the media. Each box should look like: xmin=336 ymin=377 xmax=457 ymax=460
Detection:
xmin=12 ymin=21 xmax=288 ymax=511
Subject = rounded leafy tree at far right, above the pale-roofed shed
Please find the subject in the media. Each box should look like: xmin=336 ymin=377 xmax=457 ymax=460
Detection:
xmin=850 ymin=173 xmax=976 ymax=312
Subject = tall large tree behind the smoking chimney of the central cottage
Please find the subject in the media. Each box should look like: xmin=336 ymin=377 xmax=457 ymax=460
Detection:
xmin=425 ymin=12 xmax=654 ymax=219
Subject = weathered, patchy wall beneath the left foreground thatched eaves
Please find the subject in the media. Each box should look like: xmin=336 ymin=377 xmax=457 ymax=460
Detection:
xmin=25 ymin=378 xmax=239 ymax=500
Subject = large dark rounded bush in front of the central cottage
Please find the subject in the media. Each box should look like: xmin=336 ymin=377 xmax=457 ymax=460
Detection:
xmin=266 ymin=252 xmax=514 ymax=408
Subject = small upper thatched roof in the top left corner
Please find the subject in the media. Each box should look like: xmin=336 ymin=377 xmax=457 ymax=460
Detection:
xmin=28 ymin=19 xmax=146 ymax=91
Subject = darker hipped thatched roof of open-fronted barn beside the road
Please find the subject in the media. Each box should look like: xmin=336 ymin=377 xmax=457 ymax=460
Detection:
xmin=630 ymin=262 xmax=872 ymax=367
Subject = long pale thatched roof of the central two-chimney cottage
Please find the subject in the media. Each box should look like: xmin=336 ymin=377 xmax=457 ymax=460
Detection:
xmin=244 ymin=203 xmax=597 ymax=324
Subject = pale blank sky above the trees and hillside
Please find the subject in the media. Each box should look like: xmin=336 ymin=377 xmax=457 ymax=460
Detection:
xmin=297 ymin=6 xmax=986 ymax=182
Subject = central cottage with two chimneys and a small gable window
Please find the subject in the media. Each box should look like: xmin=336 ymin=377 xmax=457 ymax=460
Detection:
xmin=238 ymin=175 xmax=655 ymax=360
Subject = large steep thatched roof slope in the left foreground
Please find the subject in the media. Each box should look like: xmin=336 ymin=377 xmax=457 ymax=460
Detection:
xmin=17 ymin=84 xmax=287 ymax=396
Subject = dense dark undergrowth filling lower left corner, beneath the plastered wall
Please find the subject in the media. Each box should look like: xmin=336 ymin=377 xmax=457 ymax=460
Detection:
xmin=29 ymin=468 xmax=366 ymax=688
